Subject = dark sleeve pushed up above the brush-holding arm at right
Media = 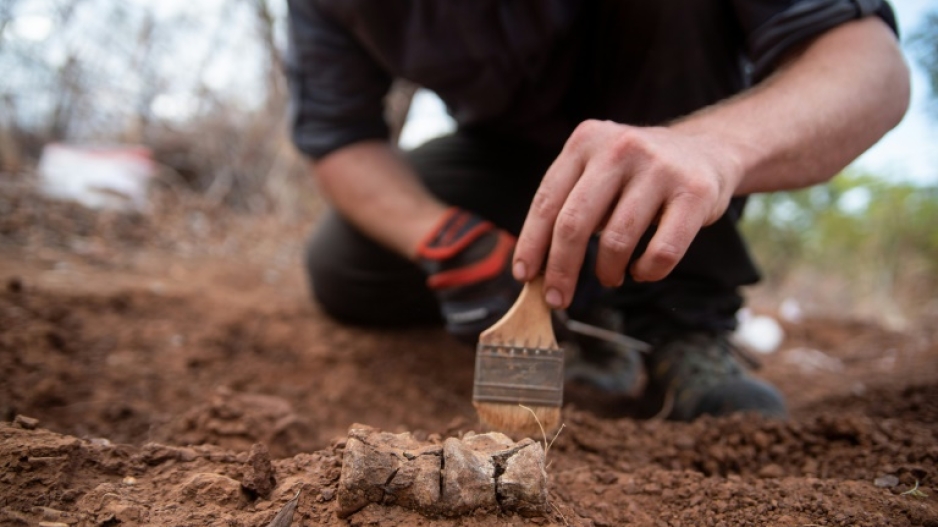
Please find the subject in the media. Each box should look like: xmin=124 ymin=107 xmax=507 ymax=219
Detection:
xmin=733 ymin=0 xmax=899 ymax=82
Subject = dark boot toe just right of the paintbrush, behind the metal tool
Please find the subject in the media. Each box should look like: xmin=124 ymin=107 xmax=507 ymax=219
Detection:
xmin=555 ymin=310 xmax=644 ymax=395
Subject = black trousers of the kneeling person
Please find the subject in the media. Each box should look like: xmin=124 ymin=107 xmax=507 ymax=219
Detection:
xmin=306 ymin=133 xmax=758 ymax=341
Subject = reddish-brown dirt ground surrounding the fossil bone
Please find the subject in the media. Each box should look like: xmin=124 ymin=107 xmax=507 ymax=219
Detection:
xmin=0 ymin=179 xmax=938 ymax=527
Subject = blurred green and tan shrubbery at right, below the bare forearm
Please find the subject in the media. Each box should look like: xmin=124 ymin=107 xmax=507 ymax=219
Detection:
xmin=742 ymin=172 xmax=938 ymax=322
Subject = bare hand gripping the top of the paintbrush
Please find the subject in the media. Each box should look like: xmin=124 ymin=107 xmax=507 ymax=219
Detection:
xmin=513 ymin=121 xmax=741 ymax=308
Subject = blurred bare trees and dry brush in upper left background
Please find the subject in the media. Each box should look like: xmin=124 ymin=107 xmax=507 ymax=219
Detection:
xmin=0 ymin=0 xmax=308 ymax=216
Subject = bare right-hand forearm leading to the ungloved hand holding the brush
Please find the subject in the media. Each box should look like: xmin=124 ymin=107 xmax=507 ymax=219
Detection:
xmin=673 ymin=17 xmax=909 ymax=195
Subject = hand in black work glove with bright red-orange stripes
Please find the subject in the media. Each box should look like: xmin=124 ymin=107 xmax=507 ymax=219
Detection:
xmin=417 ymin=207 xmax=521 ymax=344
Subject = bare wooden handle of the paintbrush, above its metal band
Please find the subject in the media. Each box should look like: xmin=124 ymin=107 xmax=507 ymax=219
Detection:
xmin=479 ymin=276 xmax=558 ymax=348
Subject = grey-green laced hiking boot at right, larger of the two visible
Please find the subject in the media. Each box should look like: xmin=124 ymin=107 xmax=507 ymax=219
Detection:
xmin=646 ymin=332 xmax=787 ymax=421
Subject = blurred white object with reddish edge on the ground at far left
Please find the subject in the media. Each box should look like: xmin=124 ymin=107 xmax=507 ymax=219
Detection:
xmin=39 ymin=143 xmax=155 ymax=212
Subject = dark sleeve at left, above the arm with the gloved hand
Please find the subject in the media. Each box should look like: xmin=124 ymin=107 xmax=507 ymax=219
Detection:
xmin=285 ymin=0 xmax=392 ymax=159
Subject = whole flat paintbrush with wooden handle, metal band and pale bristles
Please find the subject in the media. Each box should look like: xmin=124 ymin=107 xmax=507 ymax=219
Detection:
xmin=472 ymin=276 xmax=564 ymax=438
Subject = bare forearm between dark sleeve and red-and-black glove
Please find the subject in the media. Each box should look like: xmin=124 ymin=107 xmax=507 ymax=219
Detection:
xmin=313 ymin=141 xmax=446 ymax=259
